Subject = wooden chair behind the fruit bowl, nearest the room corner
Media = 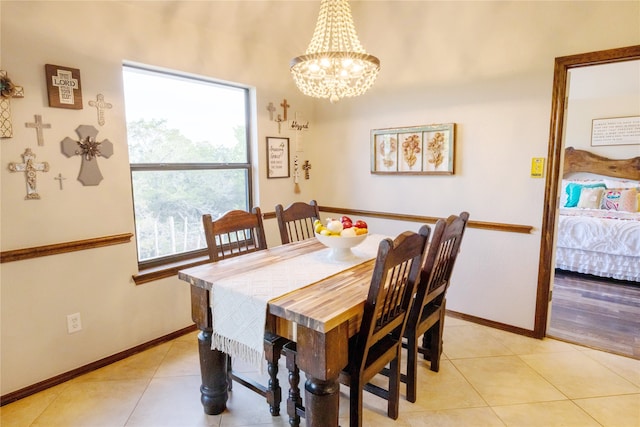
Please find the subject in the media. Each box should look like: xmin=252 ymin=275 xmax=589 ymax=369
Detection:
xmin=276 ymin=200 xmax=320 ymax=245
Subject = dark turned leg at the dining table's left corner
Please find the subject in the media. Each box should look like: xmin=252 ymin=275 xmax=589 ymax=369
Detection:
xmin=191 ymin=285 xmax=229 ymax=415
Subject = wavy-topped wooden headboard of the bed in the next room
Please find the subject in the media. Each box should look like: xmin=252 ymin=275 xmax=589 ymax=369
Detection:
xmin=562 ymin=147 xmax=640 ymax=181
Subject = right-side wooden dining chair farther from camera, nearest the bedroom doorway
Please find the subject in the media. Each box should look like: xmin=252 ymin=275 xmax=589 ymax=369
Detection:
xmin=401 ymin=212 xmax=469 ymax=402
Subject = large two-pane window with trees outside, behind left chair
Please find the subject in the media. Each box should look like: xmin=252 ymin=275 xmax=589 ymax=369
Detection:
xmin=123 ymin=64 xmax=252 ymax=269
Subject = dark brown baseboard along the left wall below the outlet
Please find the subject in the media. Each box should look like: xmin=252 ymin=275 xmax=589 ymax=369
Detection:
xmin=0 ymin=325 xmax=197 ymax=406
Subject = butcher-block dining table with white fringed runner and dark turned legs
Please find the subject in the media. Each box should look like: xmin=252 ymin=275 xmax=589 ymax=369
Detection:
xmin=178 ymin=234 xmax=386 ymax=427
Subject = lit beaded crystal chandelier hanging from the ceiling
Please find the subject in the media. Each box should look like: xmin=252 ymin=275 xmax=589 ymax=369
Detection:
xmin=290 ymin=0 xmax=380 ymax=103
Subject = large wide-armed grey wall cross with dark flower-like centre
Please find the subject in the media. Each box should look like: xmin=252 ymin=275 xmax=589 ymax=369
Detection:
xmin=61 ymin=125 xmax=113 ymax=185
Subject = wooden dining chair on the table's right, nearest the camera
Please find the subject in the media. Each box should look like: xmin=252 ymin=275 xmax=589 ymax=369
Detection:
xmin=285 ymin=225 xmax=431 ymax=427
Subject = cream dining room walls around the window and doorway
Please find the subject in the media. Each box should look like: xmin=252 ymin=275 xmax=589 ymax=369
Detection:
xmin=0 ymin=1 xmax=640 ymax=394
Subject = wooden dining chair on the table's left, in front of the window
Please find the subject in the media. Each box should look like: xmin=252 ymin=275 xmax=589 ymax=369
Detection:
xmin=202 ymin=207 xmax=288 ymax=416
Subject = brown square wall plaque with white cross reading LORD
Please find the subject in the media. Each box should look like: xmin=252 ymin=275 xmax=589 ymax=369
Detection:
xmin=44 ymin=64 xmax=82 ymax=110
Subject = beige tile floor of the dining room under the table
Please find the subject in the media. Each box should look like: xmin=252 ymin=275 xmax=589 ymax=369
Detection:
xmin=0 ymin=318 xmax=640 ymax=427
